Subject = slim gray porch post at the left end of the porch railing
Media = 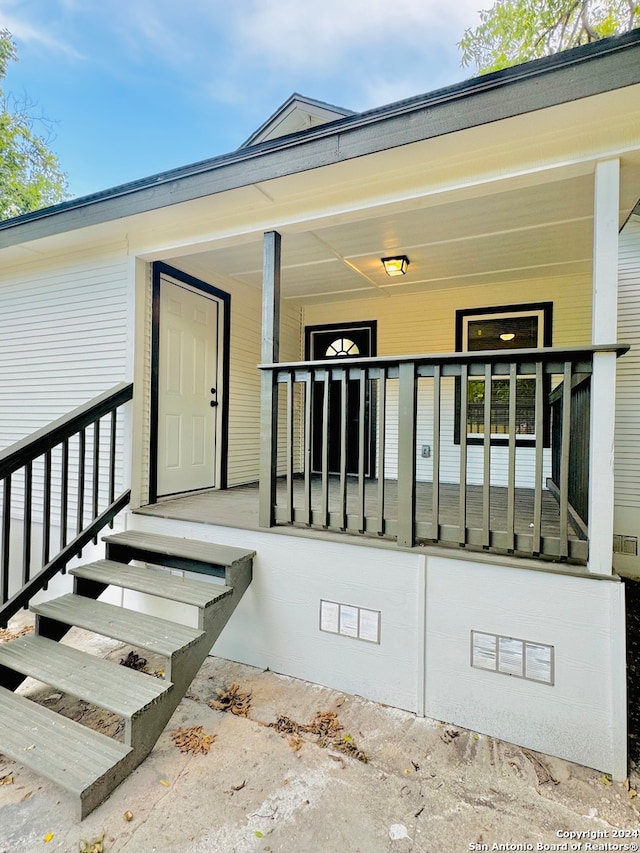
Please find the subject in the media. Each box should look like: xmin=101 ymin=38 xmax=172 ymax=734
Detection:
xmin=259 ymin=231 xmax=282 ymax=527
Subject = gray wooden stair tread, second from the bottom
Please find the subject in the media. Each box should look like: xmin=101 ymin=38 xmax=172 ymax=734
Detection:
xmin=0 ymin=634 xmax=171 ymax=718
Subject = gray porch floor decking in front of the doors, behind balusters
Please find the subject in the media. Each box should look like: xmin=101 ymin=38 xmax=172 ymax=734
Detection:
xmin=135 ymin=476 xmax=580 ymax=564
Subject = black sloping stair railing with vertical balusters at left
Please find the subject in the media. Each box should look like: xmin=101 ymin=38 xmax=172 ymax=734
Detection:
xmin=0 ymin=383 xmax=133 ymax=626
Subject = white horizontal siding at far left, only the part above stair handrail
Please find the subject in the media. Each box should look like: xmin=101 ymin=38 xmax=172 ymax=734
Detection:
xmin=0 ymin=244 xmax=127 ymax=447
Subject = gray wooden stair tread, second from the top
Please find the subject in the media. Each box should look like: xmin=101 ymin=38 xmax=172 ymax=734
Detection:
xmin=69 ymin=560 xmax=233 ymax=607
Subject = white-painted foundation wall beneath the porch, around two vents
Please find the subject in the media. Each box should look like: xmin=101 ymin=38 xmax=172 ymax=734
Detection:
xmin=128 ymin=515 xmax=626 ymax=778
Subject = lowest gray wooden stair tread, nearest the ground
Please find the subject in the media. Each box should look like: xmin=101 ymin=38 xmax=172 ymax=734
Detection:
xmin=0 ymin=687 xmax=131 ymax=794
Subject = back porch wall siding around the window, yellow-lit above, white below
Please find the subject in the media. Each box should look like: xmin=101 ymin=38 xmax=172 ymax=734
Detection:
xmin=304 ymin=276 xmax=591 ymax=487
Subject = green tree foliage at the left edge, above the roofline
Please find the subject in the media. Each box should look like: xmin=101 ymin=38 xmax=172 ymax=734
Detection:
xmin=0 ymin=29 xmax=67 ymax=219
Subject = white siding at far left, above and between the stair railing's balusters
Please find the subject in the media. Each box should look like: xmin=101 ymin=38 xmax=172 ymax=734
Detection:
xmin=0 ymin=244 xmax=128 ymax=552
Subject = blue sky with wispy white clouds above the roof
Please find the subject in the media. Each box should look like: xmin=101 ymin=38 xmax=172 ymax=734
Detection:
xmin=0 ymin=0 xmax=480 ymax=196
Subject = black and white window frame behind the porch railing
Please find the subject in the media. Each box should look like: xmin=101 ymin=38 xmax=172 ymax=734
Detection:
xmin=454 ymin=302 xmax=553 ymax=447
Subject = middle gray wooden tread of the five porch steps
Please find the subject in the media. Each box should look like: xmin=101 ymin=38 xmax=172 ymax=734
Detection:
xmin=31 ymin=593 xmax=203 ymax=657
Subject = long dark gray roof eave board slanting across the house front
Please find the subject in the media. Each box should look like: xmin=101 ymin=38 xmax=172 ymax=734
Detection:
xmin=0 ymin=29 xmax=640 ymax=248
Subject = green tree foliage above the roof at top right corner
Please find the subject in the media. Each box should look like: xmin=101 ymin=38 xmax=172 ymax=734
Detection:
xmin=459 ymin=0 xmax=640 ymax=74
